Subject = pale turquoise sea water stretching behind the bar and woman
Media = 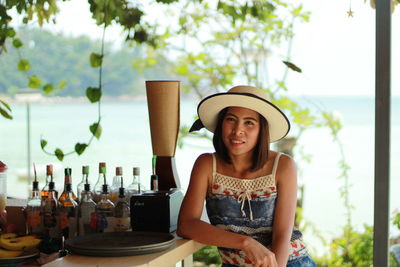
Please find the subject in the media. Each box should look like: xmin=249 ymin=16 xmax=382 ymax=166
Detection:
xmin=0 ymin=96 xmax=400 ymax=253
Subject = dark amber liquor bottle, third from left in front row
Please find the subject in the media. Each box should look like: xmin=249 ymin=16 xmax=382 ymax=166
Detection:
xmin=57 ymin=168 xmax=78 ymax=238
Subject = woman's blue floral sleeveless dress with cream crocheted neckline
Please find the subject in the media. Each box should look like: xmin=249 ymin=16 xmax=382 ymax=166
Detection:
xmin=206 ymin=153 xmax=315 ymax=267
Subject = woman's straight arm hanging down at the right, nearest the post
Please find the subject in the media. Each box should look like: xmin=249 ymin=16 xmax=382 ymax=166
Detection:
xmin=271 ymin=155 xmax=297 ymax=267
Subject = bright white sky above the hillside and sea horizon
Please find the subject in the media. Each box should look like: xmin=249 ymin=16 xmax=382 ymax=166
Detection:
xmin=10 ymin=0 xmax=400 ymax=96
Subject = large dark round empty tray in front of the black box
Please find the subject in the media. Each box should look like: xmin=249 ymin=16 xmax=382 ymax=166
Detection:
xmin=65 ymin=232 xmax=174 ymax=257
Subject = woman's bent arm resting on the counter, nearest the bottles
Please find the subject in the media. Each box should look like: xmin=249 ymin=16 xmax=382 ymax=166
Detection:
xmin=177 ymin=154 xmax=277 ymax=267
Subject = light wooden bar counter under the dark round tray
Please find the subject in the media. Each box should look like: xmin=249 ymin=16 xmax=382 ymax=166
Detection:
xmin=43 ymin=237 xmax=205 ymax=267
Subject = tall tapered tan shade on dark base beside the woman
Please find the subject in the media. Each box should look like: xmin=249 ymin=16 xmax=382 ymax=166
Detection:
xmin=146 ymin=81 xmax=180 ymax=157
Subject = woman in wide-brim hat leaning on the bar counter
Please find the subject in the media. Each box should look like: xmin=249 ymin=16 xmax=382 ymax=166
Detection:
xmin=177 ymin=86 xmax=315 ymax=267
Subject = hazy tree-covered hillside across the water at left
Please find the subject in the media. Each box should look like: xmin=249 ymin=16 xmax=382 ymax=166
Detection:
xmin=0 ymin=27 xmax=167 ymax=97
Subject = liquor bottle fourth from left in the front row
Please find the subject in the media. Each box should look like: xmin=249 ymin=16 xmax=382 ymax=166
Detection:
xmin=78 ymin=177 xmax=97 ymax=236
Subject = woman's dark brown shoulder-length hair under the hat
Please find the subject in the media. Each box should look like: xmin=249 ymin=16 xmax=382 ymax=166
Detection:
xmin=213 ymin=107 xmax=269 ymax=171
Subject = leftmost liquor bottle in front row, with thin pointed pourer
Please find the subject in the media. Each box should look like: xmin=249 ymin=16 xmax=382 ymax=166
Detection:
xmin=25 ymin=169 xmax=42 ymax=236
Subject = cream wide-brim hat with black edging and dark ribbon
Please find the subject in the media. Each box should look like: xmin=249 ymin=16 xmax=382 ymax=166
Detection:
xmin=189 ymin=85 xmax=290 ymax=142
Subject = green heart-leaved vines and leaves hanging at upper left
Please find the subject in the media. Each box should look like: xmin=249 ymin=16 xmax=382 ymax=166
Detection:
xmin=0 ymin=0 xmax=178 ymax=161
